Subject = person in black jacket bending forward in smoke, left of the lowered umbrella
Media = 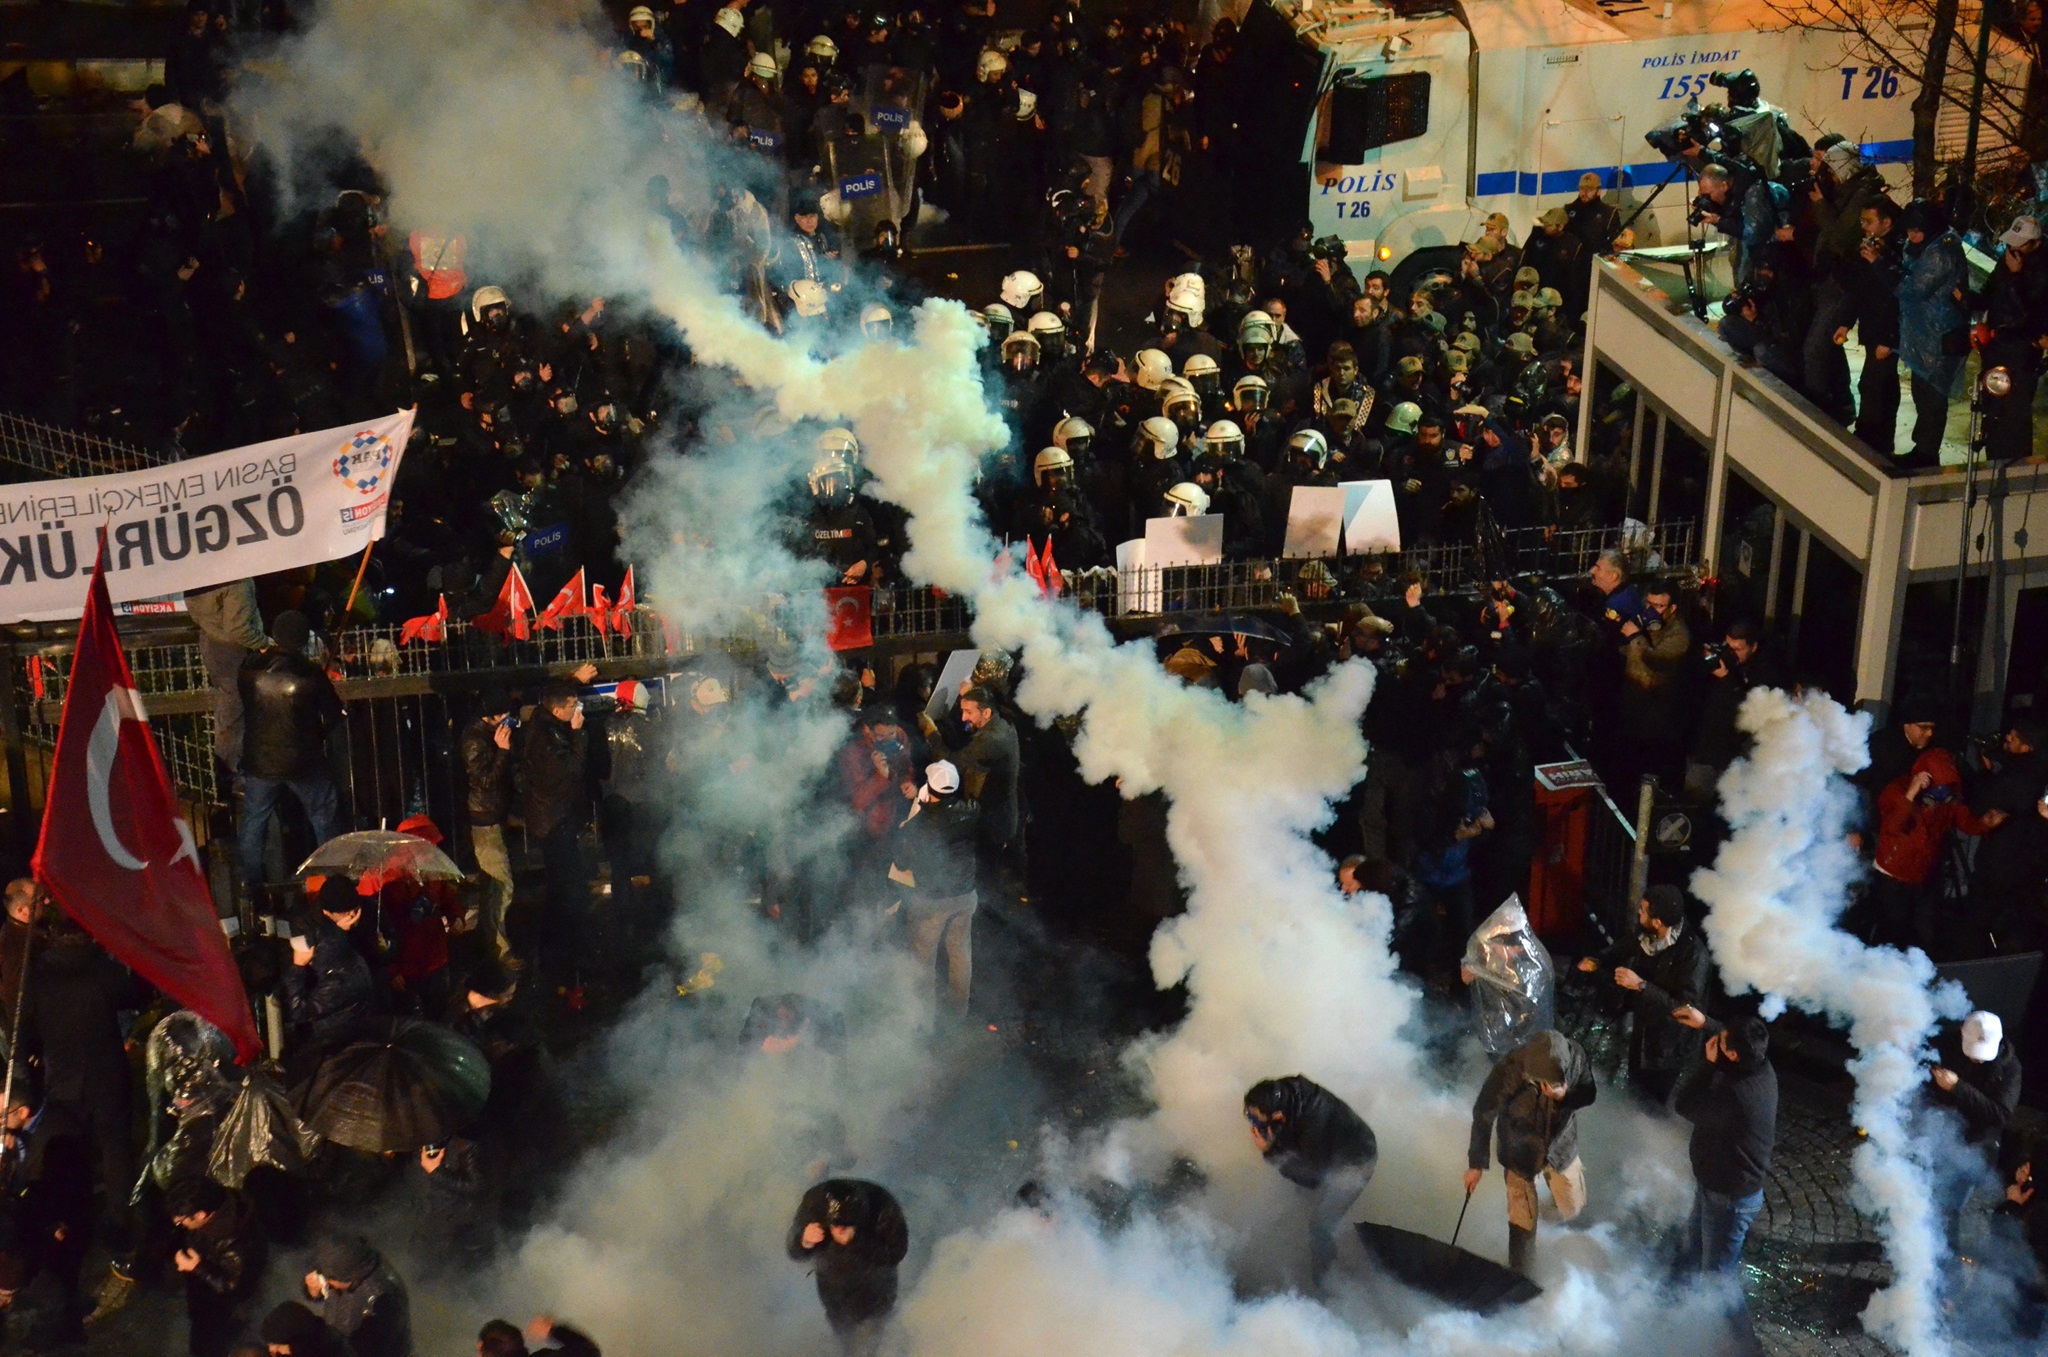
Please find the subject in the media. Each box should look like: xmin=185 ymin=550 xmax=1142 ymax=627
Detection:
xmin=1245 ymin=1075 xmax=1380 ymax=1285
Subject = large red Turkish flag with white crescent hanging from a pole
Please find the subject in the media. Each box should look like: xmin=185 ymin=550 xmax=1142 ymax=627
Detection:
xmin=35 ymin=544 xmax=262 ymax=1062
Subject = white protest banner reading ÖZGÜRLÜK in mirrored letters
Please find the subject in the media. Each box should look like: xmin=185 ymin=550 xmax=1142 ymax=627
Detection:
xmin=0 ymin=409 xmax=414 ymax=622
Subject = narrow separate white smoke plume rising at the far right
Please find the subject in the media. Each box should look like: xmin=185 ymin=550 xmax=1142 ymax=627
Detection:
xmin=1692 ymin=688 xmax=1966 ymax=1357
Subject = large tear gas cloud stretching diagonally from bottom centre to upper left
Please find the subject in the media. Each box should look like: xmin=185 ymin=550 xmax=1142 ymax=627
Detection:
xmin=238 ymin=0 xmax=1966 ymax=1357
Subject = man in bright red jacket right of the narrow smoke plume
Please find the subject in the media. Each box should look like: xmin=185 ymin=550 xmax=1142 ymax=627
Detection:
xmin=1866 ymin=749 xmax=2005 ymax=948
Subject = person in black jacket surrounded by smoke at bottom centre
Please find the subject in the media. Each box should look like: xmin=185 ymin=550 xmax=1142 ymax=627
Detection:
xmin=788 ymin=1179 xmax=909 ymax=1357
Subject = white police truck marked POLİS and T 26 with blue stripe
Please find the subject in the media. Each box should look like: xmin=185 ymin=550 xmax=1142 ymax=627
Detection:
xmin=1239 ymin=0 xmax=2028 ymax=293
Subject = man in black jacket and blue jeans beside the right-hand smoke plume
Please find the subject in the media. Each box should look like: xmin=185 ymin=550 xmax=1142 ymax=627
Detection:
xmin=1673 ymin=1015 xmax=1778 ymax=1275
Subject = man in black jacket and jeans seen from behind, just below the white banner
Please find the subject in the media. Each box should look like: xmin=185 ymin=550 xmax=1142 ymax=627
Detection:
xmin=236 ymin=612 xmax=344 ymax=890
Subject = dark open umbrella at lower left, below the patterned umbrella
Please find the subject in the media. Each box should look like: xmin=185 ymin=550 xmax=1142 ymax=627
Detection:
xmin=299 ymin=1017 xmax=492 ymax=1154
